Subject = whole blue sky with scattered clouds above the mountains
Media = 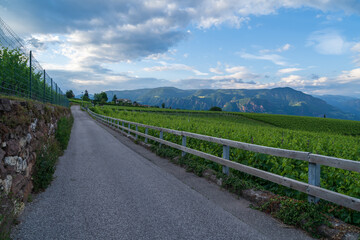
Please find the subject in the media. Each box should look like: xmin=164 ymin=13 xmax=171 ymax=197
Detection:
xmin=0 ymin=0 xmax=360 ymax=98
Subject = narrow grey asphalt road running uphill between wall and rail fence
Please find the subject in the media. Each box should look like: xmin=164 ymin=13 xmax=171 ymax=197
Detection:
xmin=12 ymin=106 xmax=309 ymax=240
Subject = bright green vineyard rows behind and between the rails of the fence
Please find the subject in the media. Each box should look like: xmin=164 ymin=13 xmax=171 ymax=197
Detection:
xmin=92 ymin=106 xmax=360 ymax=223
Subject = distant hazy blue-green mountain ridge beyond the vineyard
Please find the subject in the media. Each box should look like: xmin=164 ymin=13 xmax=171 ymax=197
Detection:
xmin=106 ymin=87 xmax=360 ymax=119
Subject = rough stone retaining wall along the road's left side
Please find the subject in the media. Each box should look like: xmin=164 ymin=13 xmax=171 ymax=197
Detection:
xmin=0 ymin=98 xmax=70 ymax=202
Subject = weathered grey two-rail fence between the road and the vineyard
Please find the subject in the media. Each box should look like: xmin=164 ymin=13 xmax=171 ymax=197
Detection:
xmin=87 ymin=109 xmax=360 ymax=211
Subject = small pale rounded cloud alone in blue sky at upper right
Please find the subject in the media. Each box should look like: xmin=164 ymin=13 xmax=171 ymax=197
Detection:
xmin=307 ymin=30 xmax=351 ymax=55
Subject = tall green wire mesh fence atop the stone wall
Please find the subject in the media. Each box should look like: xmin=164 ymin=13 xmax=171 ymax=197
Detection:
xmin=0 ymin=18 xmax=69 ymax=107
